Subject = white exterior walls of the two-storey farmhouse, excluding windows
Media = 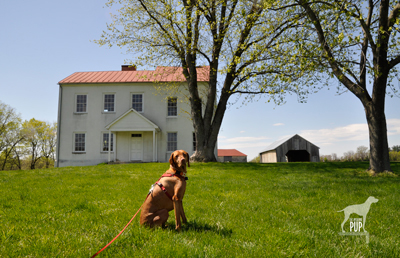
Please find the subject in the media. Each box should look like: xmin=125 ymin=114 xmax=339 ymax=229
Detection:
xmin=58 ymin=83 xmax=206 ymax=166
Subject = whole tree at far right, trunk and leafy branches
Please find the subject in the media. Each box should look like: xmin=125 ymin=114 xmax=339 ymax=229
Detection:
xmin=273 ymin=0 xmax=400 ymax=173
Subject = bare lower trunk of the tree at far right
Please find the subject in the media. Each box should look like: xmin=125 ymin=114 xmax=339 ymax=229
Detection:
xmin=365 ymin=101 xmax=391 ymax=174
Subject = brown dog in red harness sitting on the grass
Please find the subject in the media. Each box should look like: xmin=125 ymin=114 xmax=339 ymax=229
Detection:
xmin=140 ymin=150 xmax=190 ymax=231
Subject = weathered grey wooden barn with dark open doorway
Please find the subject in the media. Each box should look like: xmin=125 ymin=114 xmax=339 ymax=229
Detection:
xmin=260 ymin=134 xmax=319 ymax=163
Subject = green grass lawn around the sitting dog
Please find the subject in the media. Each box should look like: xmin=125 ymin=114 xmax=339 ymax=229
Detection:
xmin=0 ymin=163 xmax=400 ymax=257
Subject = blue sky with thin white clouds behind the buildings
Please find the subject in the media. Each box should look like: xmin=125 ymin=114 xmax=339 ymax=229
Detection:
xmin=0 ymin=0 xmax=400 ymax=159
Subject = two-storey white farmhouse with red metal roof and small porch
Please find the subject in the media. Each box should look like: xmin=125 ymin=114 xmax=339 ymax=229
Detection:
xmin=56 ymin=65 xmax=209 ymax=167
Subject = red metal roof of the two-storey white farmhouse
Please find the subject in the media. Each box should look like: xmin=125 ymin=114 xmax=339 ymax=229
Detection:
xmin=59 ymin=66 xmax=210 ymax=84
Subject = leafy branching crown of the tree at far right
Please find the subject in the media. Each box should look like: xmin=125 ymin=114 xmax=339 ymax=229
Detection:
xmin=271 ymin=0 xmax=400 ymax=96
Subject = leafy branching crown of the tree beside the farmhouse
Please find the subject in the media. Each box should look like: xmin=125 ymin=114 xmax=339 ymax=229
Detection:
xmin=95 ymin=0 xmax=313 ymax=103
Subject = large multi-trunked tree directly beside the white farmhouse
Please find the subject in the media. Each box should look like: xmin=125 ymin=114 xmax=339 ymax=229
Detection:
xmin=96 ymin=0 xmax=305 ymax=162
